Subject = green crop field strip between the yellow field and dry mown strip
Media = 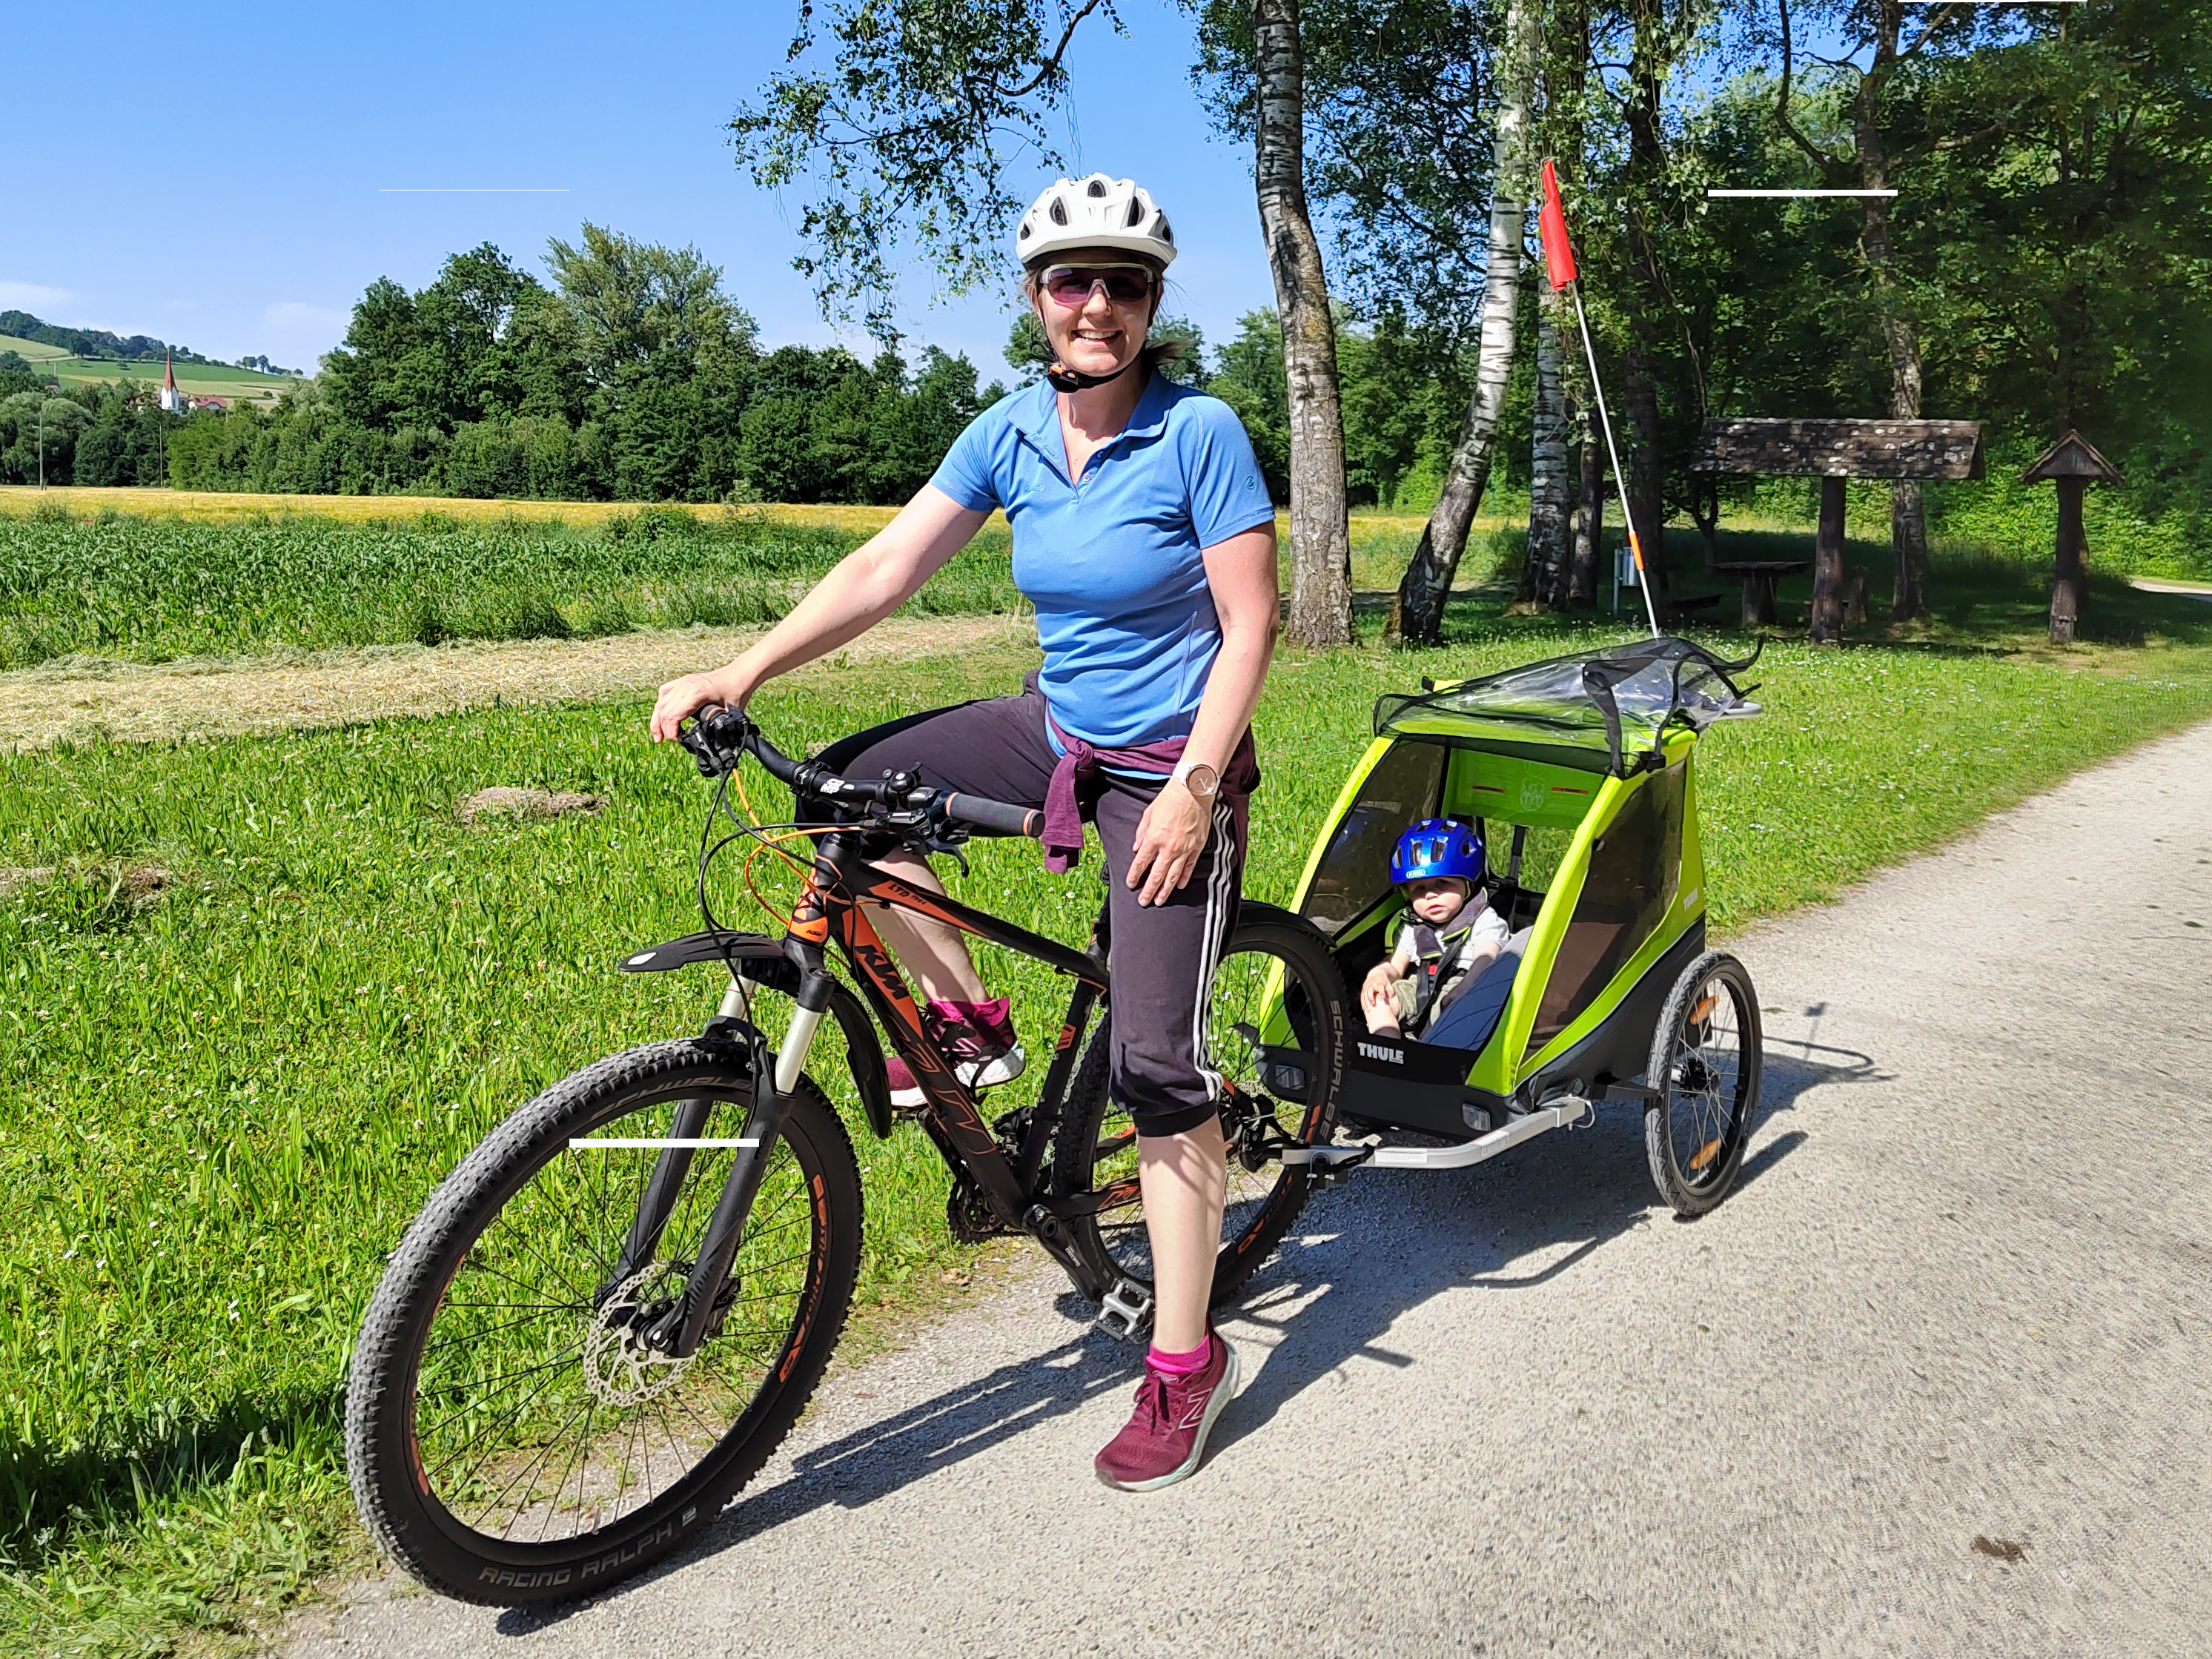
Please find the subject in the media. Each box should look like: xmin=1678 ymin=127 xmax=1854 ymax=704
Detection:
xmin=0 ymin=506 xmax=1020 ymax=668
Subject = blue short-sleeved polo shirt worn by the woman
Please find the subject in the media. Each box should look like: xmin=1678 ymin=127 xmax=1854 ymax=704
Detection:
xmin=929 ymin=374 xmax=1274 ymax=750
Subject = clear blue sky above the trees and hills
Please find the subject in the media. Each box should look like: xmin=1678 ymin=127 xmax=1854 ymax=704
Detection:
xmin=0 ymin=0 xmax=1272 ymax=378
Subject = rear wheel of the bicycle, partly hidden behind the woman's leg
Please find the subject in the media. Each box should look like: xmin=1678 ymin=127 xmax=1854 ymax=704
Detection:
xmin=1053 ymin=902 xmax=1347 ymax=1308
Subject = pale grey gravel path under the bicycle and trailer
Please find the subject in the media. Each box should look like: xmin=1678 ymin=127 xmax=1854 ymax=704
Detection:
xmin=290 ymin=726 xmax=2212 ymax=1659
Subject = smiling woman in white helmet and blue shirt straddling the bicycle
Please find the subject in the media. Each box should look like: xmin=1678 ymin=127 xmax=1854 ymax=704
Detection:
xmin=652 ymin=173 xmax=1279 ymax=1491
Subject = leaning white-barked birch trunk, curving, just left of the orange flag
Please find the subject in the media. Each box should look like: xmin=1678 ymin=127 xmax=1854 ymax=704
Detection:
xmin=1389 ymin=0 xmax=1540 ymax=646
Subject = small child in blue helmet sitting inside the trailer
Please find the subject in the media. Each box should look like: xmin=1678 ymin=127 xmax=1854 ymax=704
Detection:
xmin=1360 ymin=818 xmax=1511 ymax=1037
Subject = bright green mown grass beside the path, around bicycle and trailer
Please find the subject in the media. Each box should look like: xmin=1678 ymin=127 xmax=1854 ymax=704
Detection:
xmin=0 ymin=619 xmax=2212 ymax=1652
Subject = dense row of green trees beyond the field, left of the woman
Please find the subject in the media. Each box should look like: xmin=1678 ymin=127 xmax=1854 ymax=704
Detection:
xmin=165 ymin=223 xmax=1000 ymax=502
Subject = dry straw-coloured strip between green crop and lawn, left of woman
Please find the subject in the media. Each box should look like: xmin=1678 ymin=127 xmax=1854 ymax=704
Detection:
xmin=0 ymin=617 xmax=1037 ymax=750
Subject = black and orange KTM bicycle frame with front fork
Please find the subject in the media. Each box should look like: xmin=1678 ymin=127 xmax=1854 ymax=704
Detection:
xmin=637 ymin=827 xmax=1137 ymax=1356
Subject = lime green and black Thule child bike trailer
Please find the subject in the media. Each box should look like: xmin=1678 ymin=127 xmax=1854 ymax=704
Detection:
xmin=1263 ymin=639 xmax=1761 ymax=1214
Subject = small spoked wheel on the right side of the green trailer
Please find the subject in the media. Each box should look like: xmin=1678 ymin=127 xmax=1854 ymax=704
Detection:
xmin=1643 ymin=951 xmax=1763 ymax=1214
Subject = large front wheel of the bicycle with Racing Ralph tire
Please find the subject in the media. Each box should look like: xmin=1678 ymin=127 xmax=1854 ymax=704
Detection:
xmin=345 ymin=1039 xmax=863 ymax=1606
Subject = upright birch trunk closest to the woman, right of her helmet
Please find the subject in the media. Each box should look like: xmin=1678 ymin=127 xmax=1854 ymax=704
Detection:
xmin=1252 ymin=0 xmax=1354 ymax=646
